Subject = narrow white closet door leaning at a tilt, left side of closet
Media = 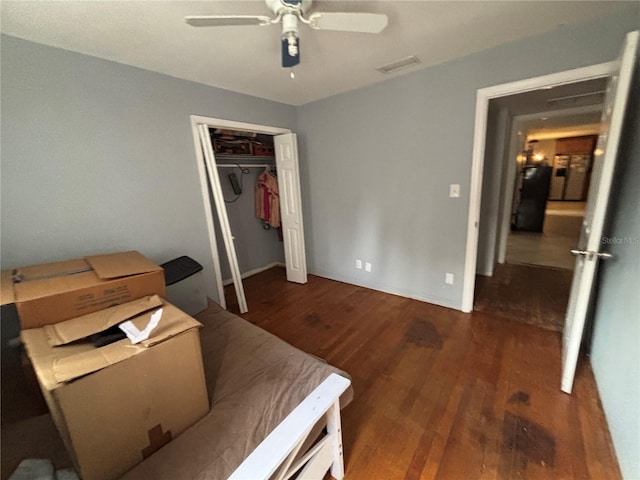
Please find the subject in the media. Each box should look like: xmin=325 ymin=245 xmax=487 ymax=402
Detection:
xmin=198 ymin=124 xmax=248 ymax=313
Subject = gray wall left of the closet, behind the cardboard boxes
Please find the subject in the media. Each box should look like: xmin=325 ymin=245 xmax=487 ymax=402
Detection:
xmin=1 ymin=36 xmax=296 ymax=299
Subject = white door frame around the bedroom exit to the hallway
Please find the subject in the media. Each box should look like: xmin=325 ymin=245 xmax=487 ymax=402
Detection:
xmin=461 ymin=61 xmax=616 ymax=313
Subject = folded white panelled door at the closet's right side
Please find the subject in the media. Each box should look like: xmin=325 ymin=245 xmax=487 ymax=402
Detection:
xmin=273 ymin=133 xmax=307 ymax=283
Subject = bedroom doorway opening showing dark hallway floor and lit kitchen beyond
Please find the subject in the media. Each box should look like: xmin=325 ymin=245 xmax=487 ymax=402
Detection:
xmin=474 ymin=101 xmax=605 ymax=332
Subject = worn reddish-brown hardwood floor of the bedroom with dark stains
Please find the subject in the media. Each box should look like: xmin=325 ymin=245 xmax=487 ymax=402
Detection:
xmin=227 ymin=268 xmax=621 ymax=480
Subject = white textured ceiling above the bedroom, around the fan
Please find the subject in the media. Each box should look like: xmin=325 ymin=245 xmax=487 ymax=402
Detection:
xmin=0 ymin=0 xmax=624 ymax=105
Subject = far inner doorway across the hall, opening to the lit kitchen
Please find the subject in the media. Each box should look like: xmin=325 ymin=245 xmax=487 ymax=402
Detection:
xmin=497 ymin=112 xmax=606 ymax=270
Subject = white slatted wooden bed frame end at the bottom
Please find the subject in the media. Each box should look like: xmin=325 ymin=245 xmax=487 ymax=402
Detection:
xmin=228 ymin=373 xmax=351 ymax=480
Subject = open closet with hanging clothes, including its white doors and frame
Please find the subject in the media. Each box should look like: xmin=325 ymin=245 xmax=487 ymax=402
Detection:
xmin=191 ymin=116 xmax=307 ymax=313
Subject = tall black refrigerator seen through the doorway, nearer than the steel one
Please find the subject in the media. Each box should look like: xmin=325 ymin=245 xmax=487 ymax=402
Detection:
xmin=511 ymin=165 xmax=552 ymax=232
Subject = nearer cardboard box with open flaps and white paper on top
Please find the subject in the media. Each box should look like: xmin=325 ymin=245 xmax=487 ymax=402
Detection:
xmin=21 ymin=296 xmax=209 ymax=480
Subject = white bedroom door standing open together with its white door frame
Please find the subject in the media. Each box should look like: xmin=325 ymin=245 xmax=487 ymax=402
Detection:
xmin=463 ymin=31 xmax=640 ymax=393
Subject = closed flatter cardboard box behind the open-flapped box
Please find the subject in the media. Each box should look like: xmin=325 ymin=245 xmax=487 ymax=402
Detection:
xmin=1 ymin=251 xmax=165 ymax=329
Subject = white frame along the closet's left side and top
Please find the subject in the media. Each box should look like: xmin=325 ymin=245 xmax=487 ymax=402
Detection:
xmin=189 ymin=115 xmax=293 ymax=309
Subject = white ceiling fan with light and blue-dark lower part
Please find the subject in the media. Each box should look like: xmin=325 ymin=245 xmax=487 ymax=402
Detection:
xmin=185 ymin=0 xmax=387 ymax=68
